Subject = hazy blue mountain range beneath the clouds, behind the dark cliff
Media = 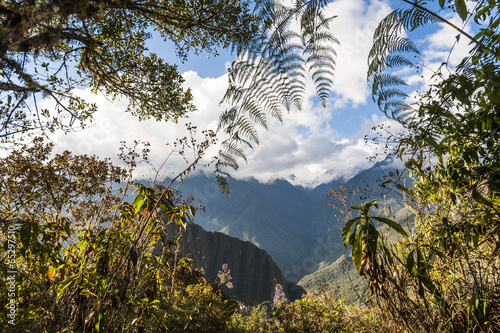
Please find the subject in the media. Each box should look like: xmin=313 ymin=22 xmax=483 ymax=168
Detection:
xmin=162 ymin=157 xmax=404 ymax=282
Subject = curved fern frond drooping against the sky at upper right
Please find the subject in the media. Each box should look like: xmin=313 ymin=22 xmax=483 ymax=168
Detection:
xmin=368 ymin=0 xmax=488 ymax=122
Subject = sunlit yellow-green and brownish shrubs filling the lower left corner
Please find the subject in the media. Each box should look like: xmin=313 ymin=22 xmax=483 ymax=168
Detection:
xmin=0 ymin=141 xmax=236 ymax=332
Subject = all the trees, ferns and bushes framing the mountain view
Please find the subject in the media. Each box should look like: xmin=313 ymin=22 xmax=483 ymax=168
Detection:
xmin=0 ymin=0 xmax=500 ymax=332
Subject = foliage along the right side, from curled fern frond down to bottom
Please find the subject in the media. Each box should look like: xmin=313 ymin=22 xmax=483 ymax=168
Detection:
xmin=343 ymin=0 xmax=500 ymax=332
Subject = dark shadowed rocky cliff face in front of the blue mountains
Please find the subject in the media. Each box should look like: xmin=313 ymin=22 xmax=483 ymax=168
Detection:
xmin=169 ymin=224 xmax=305 ymax=305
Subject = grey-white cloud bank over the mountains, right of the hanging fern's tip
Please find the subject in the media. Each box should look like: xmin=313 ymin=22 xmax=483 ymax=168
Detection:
xmin=234 ymin=110 xmax=400 ymax=187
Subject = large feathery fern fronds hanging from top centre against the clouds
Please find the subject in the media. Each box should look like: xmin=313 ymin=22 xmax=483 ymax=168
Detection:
xmin=216 ymin=0 xmax=338 ymax=191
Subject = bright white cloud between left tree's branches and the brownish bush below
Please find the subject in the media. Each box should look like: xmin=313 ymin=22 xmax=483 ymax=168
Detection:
xmin=48 ymin=72 xmax=227 ymax=182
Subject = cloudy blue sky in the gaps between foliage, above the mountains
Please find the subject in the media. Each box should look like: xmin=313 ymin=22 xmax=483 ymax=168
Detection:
xmin=48 ymin=0 xmax=470 ymax=187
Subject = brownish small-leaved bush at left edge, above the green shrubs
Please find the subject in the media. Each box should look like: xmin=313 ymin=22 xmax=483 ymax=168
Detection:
xmin=0 ymin=138 xmax=127 ymax=227
